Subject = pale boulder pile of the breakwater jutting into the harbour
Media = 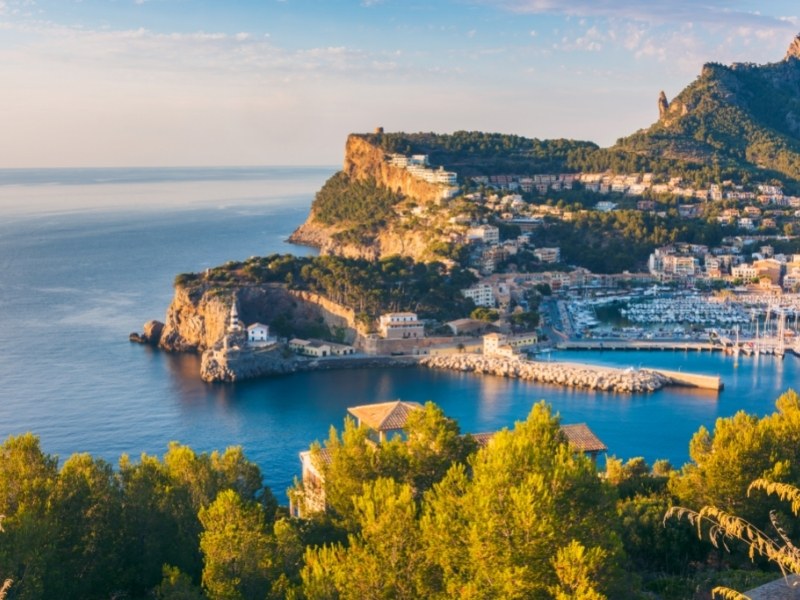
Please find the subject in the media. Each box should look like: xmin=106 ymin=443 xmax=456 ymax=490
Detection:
xmin=419 ymin=354 xmax=672 ymax=393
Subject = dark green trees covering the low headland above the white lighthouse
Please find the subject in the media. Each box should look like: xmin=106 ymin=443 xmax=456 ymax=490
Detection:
xmin=197 ymin=254 xmax=475 ymax=328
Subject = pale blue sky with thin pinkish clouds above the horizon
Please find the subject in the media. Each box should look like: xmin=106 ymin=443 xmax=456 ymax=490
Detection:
xmin=0 ymin=0 xmax=800 ymax=168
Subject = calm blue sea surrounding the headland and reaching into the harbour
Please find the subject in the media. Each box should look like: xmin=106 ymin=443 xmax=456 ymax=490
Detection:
xmin=0 ymin=167 xmax=800 ymax=502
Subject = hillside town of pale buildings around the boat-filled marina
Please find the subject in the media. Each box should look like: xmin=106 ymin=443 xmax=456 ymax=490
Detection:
xmin=370 ymin=148 xmax=800 ymax=354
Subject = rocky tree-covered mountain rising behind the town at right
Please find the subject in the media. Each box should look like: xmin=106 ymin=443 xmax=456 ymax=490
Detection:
xmin=616 ymin=36 xmax=800 ymax=182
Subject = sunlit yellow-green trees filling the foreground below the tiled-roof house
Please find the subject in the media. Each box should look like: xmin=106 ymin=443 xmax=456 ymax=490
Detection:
xmin=7 ymin=392 xmax=800 ymax=600
